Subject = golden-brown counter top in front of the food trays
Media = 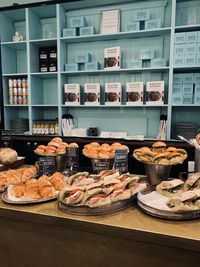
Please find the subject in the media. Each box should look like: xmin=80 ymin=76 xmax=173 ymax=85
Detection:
xmin=0 ymin=200 xmax=200 ymax=252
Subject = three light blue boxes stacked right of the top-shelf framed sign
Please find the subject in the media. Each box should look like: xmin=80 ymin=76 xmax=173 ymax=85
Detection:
xmin=127 ymin=9 xmax=161 ymax=31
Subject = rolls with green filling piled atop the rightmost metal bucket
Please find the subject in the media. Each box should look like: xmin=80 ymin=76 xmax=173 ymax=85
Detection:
xmin=133 ymin=141 xmax=187 ymax=165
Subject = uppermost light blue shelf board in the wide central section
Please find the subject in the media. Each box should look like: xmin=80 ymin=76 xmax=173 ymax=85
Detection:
xmin=60 ymin=27 xmax=171 ymax=44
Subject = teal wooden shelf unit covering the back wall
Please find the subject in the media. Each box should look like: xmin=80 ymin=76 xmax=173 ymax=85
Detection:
xmin=0 ymin=0 xmax=200 ymax=139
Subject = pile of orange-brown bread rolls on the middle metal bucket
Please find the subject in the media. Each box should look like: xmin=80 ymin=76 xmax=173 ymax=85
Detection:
xmin=82 ymin=142 xmax=129 ymax=159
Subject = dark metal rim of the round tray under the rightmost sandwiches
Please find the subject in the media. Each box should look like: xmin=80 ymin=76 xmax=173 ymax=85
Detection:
xmin=137 ymin=186 xmax=200 ymax=221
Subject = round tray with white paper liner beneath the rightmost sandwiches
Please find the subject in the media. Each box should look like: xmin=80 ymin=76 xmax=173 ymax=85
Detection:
xmin=137 ymin=186 xmax=200 ymax=221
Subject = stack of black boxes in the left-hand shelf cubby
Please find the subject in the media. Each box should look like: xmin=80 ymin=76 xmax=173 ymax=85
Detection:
xmin=39 ymin=47 xmax=57 ymax=72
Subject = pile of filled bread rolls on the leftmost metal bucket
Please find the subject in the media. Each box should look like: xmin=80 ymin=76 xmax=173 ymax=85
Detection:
xmin=35 ymin=137 xmax=78 ymax=156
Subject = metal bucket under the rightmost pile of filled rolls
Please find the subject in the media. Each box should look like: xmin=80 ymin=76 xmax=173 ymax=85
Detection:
xmin=144 ymin=163 xmax=172 ymax=185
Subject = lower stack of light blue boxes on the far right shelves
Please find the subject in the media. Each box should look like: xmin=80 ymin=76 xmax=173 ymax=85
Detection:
xmin=172 ymin=73 xmax=200 ymax=105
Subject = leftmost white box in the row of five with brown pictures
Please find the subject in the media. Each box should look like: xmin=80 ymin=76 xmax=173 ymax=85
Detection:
xmin=64 ymin=83 xmax=80 ymax=106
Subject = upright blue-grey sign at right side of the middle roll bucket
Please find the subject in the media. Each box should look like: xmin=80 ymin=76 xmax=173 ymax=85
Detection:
xmin=114 ymin=149 xmax=128 ymax=173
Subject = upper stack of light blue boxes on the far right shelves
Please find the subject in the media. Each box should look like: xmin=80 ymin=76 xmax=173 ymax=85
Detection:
xmin=174 ymin=31 xmax=200 ymax=67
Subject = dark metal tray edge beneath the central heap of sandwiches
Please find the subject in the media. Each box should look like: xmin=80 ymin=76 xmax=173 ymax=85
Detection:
xmin=58 ymin=196 xmax=136 ymax=218
